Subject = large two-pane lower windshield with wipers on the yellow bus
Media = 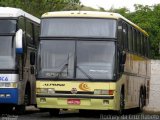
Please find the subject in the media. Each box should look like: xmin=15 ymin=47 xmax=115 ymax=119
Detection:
xmin=38 ymin=40 xmax=115 ymax=79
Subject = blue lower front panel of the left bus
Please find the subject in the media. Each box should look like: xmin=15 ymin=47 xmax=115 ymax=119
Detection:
xmin=0 ymin=88 xmax=18 ymax=104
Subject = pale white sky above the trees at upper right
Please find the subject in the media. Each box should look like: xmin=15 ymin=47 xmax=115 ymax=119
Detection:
xmin=80 ymin=0 xmax=160 ymax=11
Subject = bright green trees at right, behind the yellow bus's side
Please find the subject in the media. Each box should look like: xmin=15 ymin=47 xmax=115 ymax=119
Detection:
xmin=101 ymin=4 xmax=160 ymax=59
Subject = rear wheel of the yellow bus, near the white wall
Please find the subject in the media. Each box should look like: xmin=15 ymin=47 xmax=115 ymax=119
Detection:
xmin=138 ymin=89 xmax=145 ymax=112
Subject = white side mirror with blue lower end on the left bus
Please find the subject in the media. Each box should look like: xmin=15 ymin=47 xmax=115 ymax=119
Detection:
xmin=15 ymin=29 xmax=23 ymax=54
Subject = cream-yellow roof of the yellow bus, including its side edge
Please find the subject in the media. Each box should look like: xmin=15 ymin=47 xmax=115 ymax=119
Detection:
xmin=41 ymin=11 xmax=148 ymax=36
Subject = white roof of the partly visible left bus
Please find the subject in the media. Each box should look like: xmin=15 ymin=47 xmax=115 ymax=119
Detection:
xmin=0 ymin=7 xmax=40 ymax=23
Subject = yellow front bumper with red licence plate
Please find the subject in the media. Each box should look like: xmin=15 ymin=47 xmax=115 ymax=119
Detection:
xmin=36 ymin=97 xmax=116 ymax=110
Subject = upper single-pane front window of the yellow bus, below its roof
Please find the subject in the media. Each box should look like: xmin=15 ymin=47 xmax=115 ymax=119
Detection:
xmin=41 ymin=18 xmax=116 ymax=38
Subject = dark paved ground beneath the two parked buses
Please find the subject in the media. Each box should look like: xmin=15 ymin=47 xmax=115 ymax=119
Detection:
xmin=0 ymin=107 xmax=160 ymax=120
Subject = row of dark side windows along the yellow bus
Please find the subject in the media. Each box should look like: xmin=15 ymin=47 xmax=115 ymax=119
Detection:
xmin=117 ymin=19 xmax=149 ymax=58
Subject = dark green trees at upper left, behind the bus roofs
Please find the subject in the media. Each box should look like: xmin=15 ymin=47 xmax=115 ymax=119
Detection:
xmin=0 ymin=0 xmax=80 ymax=17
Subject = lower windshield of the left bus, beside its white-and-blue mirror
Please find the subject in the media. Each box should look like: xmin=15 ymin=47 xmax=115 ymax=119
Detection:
xmin=0 ymin=36 xmax=15 ymax=69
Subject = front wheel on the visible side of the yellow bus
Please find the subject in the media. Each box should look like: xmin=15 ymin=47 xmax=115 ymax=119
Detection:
xmin=118 ymin=92 xmax=125 ymax=115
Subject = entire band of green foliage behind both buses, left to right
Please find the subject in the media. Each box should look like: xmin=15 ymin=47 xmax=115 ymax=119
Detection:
xmin=0 ymin=0 xmax=160 ymax=59
